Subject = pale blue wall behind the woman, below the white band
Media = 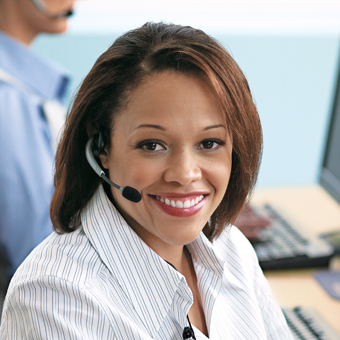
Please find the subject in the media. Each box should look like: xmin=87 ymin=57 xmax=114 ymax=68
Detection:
xmin=34 ymin=30 xmax=339 ymax=187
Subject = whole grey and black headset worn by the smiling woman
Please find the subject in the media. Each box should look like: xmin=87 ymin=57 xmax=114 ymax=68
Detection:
xmin=85 ymin=132 xmax=142 ymax=203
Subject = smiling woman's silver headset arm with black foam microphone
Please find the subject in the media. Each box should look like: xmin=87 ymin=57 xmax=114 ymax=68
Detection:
xmin=85 ymin=137 xmax=142 ymax=203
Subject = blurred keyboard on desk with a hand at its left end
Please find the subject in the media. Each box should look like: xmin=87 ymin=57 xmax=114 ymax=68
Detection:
xmin=252 ymin=204 xmax=334 ymax=270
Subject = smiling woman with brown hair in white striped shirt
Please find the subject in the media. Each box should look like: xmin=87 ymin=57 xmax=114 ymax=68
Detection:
xmin=1 ymin=23 xmax=291 ymax=340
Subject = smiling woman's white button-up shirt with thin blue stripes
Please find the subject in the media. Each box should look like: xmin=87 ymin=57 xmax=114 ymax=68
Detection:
xmin=0 ymin=186 xmax=292 ymax=340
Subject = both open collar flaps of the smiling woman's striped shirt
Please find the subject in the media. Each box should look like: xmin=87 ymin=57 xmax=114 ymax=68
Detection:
xmin=81 ymin=185 xmax=242 ymax=336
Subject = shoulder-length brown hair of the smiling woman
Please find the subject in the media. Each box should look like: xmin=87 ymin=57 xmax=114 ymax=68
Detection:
xmin=50 ymin=23 xmax=262 ymax=240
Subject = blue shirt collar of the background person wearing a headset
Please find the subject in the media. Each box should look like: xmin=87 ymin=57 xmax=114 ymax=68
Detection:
xmin=0 ymin=32 xmax=69 ymax=101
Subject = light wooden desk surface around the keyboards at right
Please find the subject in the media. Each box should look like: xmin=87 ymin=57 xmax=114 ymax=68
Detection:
xmin=251 ymin=185 xmax=340 ymax=334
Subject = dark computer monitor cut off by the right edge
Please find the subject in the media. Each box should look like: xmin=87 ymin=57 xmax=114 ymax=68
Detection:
xmin=320 ymin=52 xmax=340 ymax=204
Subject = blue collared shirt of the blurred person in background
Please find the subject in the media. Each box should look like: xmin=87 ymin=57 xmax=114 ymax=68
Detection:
xmin=0 ymin=32 xmax=68 ymax=275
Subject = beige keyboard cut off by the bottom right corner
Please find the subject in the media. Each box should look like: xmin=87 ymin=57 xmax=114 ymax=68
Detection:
xmin=282 ymin=307 xmax=340 ymax=340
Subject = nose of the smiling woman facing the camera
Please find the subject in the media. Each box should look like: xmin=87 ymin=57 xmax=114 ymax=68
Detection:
xmin=164 ymin=150 xmax=202 ymax=185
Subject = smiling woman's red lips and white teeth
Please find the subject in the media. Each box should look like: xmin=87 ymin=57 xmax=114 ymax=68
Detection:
xmin=152 ymin=194 xmax=206 ymax=217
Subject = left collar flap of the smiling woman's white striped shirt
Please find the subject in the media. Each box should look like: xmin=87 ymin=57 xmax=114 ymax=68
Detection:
xmin=81 ymin=185 xmax=187 ymax=335
